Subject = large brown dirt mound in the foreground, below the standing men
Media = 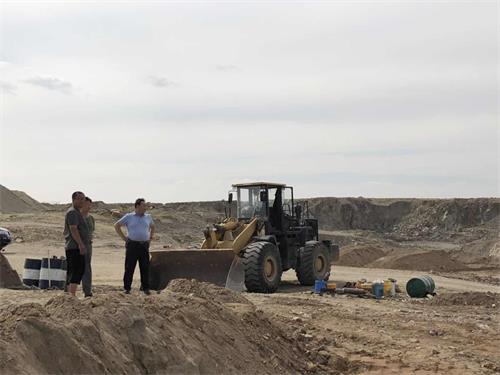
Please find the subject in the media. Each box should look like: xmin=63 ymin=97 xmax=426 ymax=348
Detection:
xmin=0 ymin=281 xmax=308 ymax=374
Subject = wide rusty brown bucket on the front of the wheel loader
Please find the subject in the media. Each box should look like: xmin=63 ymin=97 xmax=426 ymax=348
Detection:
xmin=149 ymin=249 xmax=235 ymax=290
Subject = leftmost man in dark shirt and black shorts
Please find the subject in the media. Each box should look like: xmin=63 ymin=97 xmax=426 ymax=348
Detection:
xmin=64 ymin=191 xmax=89 ymax=296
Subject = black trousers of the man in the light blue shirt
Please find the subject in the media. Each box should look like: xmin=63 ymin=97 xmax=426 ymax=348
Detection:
xmin=123 ymin=240 xmax=149 ymax=290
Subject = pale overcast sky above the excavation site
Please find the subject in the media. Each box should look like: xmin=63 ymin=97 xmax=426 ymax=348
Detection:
xmin=0 ymin=1 xmax=500 ymax=202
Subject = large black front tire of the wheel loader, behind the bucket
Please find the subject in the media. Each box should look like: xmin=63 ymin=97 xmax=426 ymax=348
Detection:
xmin=243 ymin=241 xmax=283 ymax=293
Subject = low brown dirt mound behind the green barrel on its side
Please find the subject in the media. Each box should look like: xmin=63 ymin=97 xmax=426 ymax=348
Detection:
xmin=370 ymin=250 xmax=468 ymax=271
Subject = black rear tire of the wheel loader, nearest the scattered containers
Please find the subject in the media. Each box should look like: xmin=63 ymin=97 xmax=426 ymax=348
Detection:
xmin=295 ymin=241 xmax=331 ymax=285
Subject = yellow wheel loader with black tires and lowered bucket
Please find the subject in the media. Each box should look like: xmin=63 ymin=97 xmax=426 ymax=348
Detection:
xmin=150 ymin=182 xmax=339 ymax=293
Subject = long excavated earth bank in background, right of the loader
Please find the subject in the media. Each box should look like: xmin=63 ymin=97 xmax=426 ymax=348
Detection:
xmin=309 ymin=198 xmax=500 ymax=237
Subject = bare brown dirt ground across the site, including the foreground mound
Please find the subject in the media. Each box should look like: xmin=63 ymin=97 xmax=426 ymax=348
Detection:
xmin=0 ymin=192 xmax=500 ymax=374
